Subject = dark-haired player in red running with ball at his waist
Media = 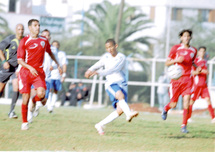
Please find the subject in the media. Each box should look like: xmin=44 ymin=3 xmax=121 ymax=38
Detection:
xmin=161 ymin=29 xmax=197 ymax=133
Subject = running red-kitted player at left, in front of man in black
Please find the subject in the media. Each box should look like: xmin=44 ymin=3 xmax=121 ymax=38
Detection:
xmin=17 ymin=19 xmax=62 ymax=130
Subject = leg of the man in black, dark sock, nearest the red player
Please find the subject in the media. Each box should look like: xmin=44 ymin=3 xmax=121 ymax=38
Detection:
xmin=8 ymin=77 xmax=19 ymax=119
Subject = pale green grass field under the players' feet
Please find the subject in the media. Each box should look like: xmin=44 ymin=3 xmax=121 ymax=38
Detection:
xmin=0 ymin=105 xmax=215 ymax=152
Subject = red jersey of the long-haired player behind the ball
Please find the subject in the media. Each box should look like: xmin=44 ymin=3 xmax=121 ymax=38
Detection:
xmin=168 ymin=44 xmax=197 ymax=76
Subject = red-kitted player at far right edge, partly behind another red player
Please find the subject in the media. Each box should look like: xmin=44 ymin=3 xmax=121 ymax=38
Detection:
xmin=188 ymin=46 xmax=215 ymax=123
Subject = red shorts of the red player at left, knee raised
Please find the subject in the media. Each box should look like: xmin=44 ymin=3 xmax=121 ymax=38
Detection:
xmin=18 ymin=68 xmax=46 ymax=93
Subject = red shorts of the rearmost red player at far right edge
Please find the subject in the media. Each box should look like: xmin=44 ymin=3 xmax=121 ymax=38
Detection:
xmin=191 ymin=85 xmax=210 ymax=101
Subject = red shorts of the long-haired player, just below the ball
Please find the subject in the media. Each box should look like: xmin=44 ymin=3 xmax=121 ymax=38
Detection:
xmin=169 ymin=76 xmax=193 ymax=102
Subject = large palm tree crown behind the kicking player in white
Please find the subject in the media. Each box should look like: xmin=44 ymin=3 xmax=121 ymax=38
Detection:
xmin=73 ymin=1 xmax=151 ymax=55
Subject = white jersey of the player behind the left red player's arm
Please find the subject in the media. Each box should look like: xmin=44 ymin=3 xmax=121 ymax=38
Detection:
xmin=51 ymin=49 xmax=68 ymax=80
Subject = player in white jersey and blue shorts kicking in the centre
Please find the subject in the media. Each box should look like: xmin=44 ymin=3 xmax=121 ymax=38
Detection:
xmin=85 ymin=39 xmax=139 ymax=135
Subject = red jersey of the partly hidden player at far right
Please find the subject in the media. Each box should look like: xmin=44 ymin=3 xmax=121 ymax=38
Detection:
xmin=193 ymin=57 xmax=207 ymax=86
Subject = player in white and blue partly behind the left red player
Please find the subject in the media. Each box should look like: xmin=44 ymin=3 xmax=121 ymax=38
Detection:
xmin=47 ymin=40 xmax=68 ymax=113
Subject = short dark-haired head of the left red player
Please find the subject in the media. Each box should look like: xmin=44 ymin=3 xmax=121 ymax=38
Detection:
xmin=28 ymin=19 xmax=40 ymax=36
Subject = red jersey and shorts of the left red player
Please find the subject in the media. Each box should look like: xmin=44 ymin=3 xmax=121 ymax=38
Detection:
xmin=17 ymin=35 xmax=51 ymax=93
